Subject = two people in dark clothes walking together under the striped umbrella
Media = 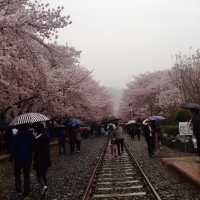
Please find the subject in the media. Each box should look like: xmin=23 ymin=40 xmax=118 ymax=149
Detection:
xmin=10 ymin=123 xmax=51 ymax=197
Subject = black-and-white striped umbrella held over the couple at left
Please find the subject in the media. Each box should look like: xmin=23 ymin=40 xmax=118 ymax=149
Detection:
xmin=10 ymin=113 xmax=49 ymax=126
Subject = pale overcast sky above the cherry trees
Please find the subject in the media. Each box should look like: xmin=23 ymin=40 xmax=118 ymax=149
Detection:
xmin=43 ymin=0 xmax=200 ymax=88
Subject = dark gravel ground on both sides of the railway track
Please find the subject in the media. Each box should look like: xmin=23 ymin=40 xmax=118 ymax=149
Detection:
xmin=0 ymin=134 xmax=200 ymax=200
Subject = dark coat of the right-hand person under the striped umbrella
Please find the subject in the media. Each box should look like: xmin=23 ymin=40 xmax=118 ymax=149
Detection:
xmin=33 ymin=133 xmax=51 ymax=170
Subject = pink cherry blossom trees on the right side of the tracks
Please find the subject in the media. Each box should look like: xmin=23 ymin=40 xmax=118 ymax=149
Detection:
xmin=119 ymin=70 xmax=182 ymax=120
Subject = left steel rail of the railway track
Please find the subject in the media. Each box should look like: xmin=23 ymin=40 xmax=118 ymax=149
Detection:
xmin=82 ymin=140 xmax=109 ymax=200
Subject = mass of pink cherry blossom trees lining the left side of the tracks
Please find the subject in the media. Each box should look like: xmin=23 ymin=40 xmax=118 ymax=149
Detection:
xmin=0 ymin=0 xmax=112 ymax=119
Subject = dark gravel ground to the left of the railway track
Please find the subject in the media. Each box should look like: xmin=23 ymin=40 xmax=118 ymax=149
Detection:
xmin=0 ymin=137 xmax=106 ymax=200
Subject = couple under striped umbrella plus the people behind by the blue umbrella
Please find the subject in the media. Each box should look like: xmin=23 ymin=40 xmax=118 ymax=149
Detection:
xmin=5 ymin=121 xmax=85 ymax=197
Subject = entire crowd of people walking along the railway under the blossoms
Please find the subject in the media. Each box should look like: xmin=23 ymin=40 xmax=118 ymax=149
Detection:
xmin=1 ymin=109 xmax=200 ymax=197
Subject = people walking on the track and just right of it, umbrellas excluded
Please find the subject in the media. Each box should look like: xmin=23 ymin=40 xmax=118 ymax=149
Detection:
xmin=108 ymin=119 xmax=161 ymax=158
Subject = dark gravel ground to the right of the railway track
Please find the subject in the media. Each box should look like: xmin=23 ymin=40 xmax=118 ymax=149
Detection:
xmin=125 ymin=135 xmax=200 ymax=200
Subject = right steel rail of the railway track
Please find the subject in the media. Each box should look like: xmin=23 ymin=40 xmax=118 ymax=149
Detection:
xmin=124 ymin=144 xmax=162 ymax=200
